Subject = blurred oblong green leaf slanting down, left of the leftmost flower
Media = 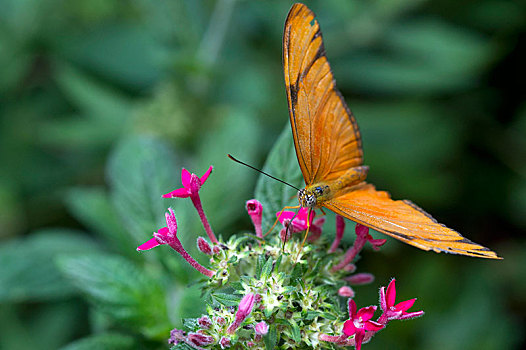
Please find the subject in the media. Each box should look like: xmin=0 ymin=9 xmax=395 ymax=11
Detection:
xmin=66 ymin=187 xmax=140 ymax=258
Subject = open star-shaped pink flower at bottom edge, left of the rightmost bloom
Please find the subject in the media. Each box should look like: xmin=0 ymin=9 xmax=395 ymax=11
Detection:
xmin=343 ymin=299 xmax=385 ymax=350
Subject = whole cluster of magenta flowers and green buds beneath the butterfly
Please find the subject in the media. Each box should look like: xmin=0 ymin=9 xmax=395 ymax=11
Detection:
xmin=137 ymin=167 xmax=423 ymax=350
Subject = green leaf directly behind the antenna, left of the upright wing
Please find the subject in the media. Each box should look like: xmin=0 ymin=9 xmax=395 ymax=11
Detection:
xmin=254 ymin=123 xmax=304 ymax=232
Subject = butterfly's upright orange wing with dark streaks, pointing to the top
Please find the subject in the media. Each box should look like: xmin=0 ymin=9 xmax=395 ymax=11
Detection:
xmin=283 ymin=4 xmax=363 ymax=185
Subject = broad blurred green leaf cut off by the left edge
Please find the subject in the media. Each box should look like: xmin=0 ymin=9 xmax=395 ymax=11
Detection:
xmin=0 ymin=229 xmax=98 ymax=302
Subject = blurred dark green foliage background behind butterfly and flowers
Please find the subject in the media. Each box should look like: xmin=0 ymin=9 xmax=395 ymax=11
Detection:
xmin=0 ymin=0 xmax=526 ymax=349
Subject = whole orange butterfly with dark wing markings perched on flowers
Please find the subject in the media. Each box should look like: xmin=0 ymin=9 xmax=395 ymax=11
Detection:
xmin=283 ymin=4 xmax=499 ymax=259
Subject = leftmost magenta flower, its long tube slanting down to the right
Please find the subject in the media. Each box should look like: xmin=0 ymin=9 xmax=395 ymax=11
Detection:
xmin=137 ymin=208 xmax=218 ymax=277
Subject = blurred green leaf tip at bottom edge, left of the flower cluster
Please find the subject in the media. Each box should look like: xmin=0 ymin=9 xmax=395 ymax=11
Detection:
xmin=61 ymin=333 xmax=137 ymax=350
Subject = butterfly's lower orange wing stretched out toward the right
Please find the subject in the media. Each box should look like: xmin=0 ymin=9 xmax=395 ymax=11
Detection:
xmin=323 ymin=183 xmax=500 ymax=259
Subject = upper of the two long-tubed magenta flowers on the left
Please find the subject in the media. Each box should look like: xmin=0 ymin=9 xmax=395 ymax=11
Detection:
xmin=163 ymin=166 xmax=217 ymax=243
